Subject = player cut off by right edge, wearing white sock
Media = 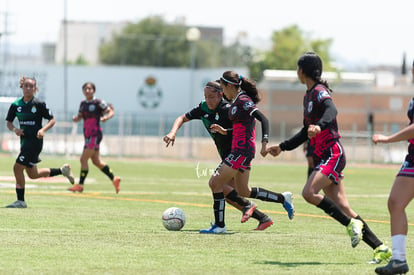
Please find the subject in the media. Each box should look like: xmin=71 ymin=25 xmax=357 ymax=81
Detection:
xmin=372 ymin=59 xmax=414 ymax=274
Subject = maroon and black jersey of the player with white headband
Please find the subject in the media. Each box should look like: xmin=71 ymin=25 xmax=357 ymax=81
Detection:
xmin=229 ymin=92 xmax=257 ymax=158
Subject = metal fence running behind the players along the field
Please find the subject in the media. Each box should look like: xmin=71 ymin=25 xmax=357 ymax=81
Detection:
xmin=0 ymin=106 xmax=408 ymax=163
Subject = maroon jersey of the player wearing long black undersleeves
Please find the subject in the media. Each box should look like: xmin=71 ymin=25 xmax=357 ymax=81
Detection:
xmin=303 ymin=84 xmax=341 ymax=157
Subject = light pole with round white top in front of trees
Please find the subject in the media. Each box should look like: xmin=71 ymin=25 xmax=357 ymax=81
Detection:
xmin=184 ymin=27 xmax=201 ymax=157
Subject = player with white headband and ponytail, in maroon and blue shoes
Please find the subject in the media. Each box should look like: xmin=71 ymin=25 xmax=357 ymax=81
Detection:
xmin=200 ymin=71 xmax=294 ymax=234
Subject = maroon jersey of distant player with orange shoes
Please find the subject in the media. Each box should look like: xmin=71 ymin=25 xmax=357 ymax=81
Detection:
xmin=79 ymin=98 xmax=108 ymax=137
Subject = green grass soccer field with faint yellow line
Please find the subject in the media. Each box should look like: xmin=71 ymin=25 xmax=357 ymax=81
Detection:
xmin=0 ymin=156 xmax=414 ymax=274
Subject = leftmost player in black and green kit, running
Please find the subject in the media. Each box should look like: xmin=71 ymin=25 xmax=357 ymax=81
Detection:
xmin=6 ymin=77 xmax=74 ymax=208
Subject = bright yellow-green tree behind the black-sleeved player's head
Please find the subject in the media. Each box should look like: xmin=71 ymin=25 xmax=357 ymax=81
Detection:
xmin=248 ymin=25 xmax=332 ymax=80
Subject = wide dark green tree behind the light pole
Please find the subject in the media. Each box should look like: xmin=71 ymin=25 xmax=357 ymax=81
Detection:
xmin=99 ymin=16 xmax=252 ymax=68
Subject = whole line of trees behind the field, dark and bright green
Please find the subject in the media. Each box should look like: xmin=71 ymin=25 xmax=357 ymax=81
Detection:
xmin=89 ymin=16 xmax=332 ymax=81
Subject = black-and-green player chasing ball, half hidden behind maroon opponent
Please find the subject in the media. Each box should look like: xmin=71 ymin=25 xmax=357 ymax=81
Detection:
xmin=164 ymin=81 xmax=273 ymax=230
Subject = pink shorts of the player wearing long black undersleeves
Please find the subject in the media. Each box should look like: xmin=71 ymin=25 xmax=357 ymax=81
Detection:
xmin=315 ymin=141 xmax=346 ymax=184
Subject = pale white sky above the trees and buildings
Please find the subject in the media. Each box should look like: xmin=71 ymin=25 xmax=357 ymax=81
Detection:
xmin=0 ymin=0 xmax=414 ymax=67
